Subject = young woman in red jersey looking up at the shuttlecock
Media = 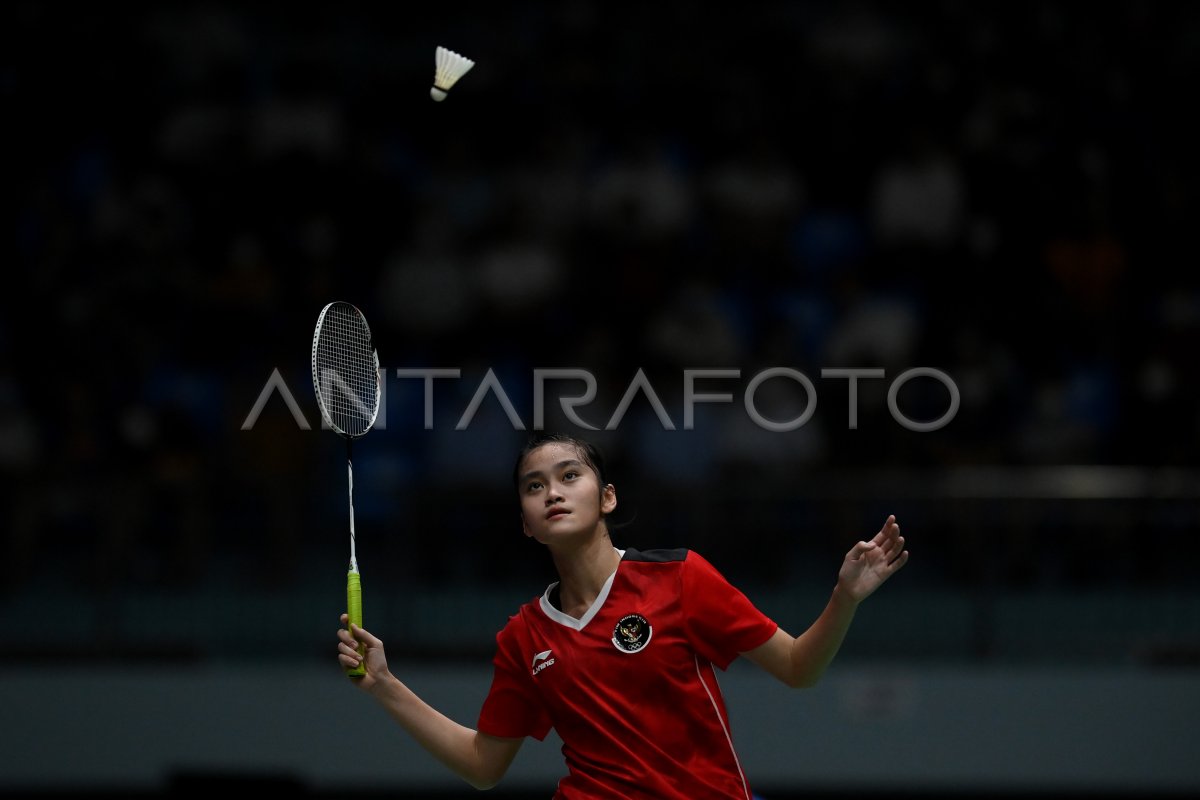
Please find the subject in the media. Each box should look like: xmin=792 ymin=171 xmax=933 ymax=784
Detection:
xmin=337 ymin=435 xmax=908 ymax=800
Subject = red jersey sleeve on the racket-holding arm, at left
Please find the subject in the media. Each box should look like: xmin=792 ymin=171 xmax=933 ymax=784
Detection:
xmin=478 ymin=614 xmax=552 ymax=741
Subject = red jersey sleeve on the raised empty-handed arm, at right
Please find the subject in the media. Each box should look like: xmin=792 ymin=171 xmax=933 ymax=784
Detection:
xmin=680 ymin=551 xmax=779 ymax=669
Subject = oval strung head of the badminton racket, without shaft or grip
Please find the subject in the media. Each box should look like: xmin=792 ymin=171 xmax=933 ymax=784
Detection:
xmin=312 ymin=300 xmax=383 ymax=439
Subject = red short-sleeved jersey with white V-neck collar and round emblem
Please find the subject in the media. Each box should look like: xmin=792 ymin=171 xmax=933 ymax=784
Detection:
xmin=479 ymin=549 xmax=778 ymax=800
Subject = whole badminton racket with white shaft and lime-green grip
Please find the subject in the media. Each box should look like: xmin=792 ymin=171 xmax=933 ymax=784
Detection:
xmin=312 ymin=301 xmax=382 ymax=678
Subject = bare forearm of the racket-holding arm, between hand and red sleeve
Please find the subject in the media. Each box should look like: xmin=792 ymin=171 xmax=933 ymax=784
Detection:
xmin=371 ymin=676 xmax=508 ymax=789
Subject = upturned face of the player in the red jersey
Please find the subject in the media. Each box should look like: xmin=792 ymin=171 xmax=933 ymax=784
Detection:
xmin=517 ymin=443 xmax=617 ymax=545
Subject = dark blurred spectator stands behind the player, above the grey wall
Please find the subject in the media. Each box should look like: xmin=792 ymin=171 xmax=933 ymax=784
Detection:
xmin=0 ymin=1 xmax=1200 ymax=796
